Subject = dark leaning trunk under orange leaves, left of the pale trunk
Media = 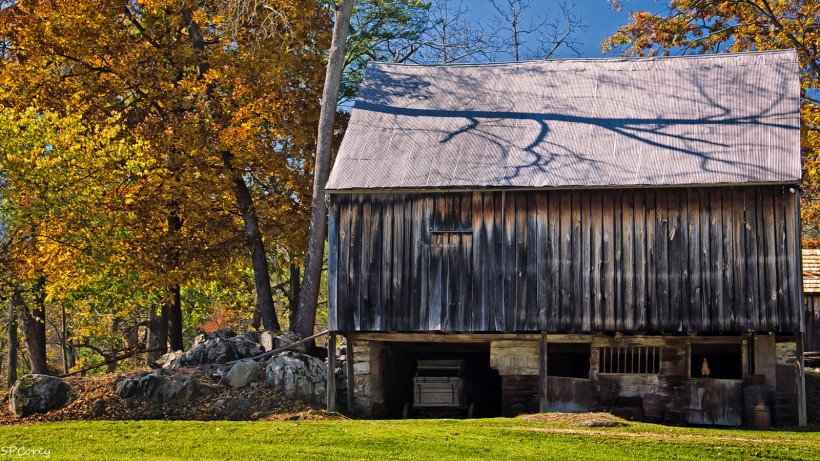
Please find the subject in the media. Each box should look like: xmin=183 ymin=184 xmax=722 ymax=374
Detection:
xmin=221 ymin=151 xmax=281 ymax=331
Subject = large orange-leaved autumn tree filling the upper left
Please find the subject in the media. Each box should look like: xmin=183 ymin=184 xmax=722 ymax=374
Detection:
xmin=0 ymin=0 xmax=334 ymax=349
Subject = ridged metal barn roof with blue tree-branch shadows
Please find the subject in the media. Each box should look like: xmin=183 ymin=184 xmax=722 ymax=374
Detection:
xmin=327 ymin=51 xmax=800 ymax=191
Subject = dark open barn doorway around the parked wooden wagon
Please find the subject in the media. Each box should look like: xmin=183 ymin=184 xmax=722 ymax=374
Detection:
xmin=381 ymin=342 xmax=501 ymax=418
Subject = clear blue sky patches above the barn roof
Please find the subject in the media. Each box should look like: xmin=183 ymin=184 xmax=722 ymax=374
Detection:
xmin=464 ymin=0 xmax=667 ymax=58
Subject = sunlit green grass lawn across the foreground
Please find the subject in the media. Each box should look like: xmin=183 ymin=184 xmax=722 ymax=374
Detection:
xmin=0 ymin=418 xmax=820 ymax=461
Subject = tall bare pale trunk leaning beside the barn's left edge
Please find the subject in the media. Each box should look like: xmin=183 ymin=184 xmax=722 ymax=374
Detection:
xmin=298 ymin=0 xmax=355 ymax=337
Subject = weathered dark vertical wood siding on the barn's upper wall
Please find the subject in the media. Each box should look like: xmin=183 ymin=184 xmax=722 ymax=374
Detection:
xmin=328 ymin=186 xmax=802 ymax=332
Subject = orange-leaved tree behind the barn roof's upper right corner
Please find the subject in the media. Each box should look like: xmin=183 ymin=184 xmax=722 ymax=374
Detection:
xmin=603 ymin=0 xmax=820 ymax=246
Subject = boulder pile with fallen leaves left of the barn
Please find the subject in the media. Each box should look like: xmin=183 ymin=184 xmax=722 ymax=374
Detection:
xmin=0 ymin=330 xmax=334 ymax=424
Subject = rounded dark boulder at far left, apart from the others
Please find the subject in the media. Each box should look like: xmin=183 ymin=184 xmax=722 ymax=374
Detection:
xmin=9 ymin=374 xmax=73 ymax=418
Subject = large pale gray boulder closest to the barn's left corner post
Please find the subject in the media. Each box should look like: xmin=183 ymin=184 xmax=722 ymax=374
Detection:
xmin=265 ymin=351 xmax=327 ymax=404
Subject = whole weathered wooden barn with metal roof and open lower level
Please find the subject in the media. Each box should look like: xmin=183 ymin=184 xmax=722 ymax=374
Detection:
xmin=327 ymin=51 xmax=805 ymax=425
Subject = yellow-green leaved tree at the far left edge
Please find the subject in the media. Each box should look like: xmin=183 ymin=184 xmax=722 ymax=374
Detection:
xmin=0 ymin=109 xmax=139 ymax=373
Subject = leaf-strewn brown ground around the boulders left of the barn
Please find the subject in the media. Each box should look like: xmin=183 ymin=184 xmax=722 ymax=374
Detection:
xmin=0 ymin=368 xmax=336 ymax=425
